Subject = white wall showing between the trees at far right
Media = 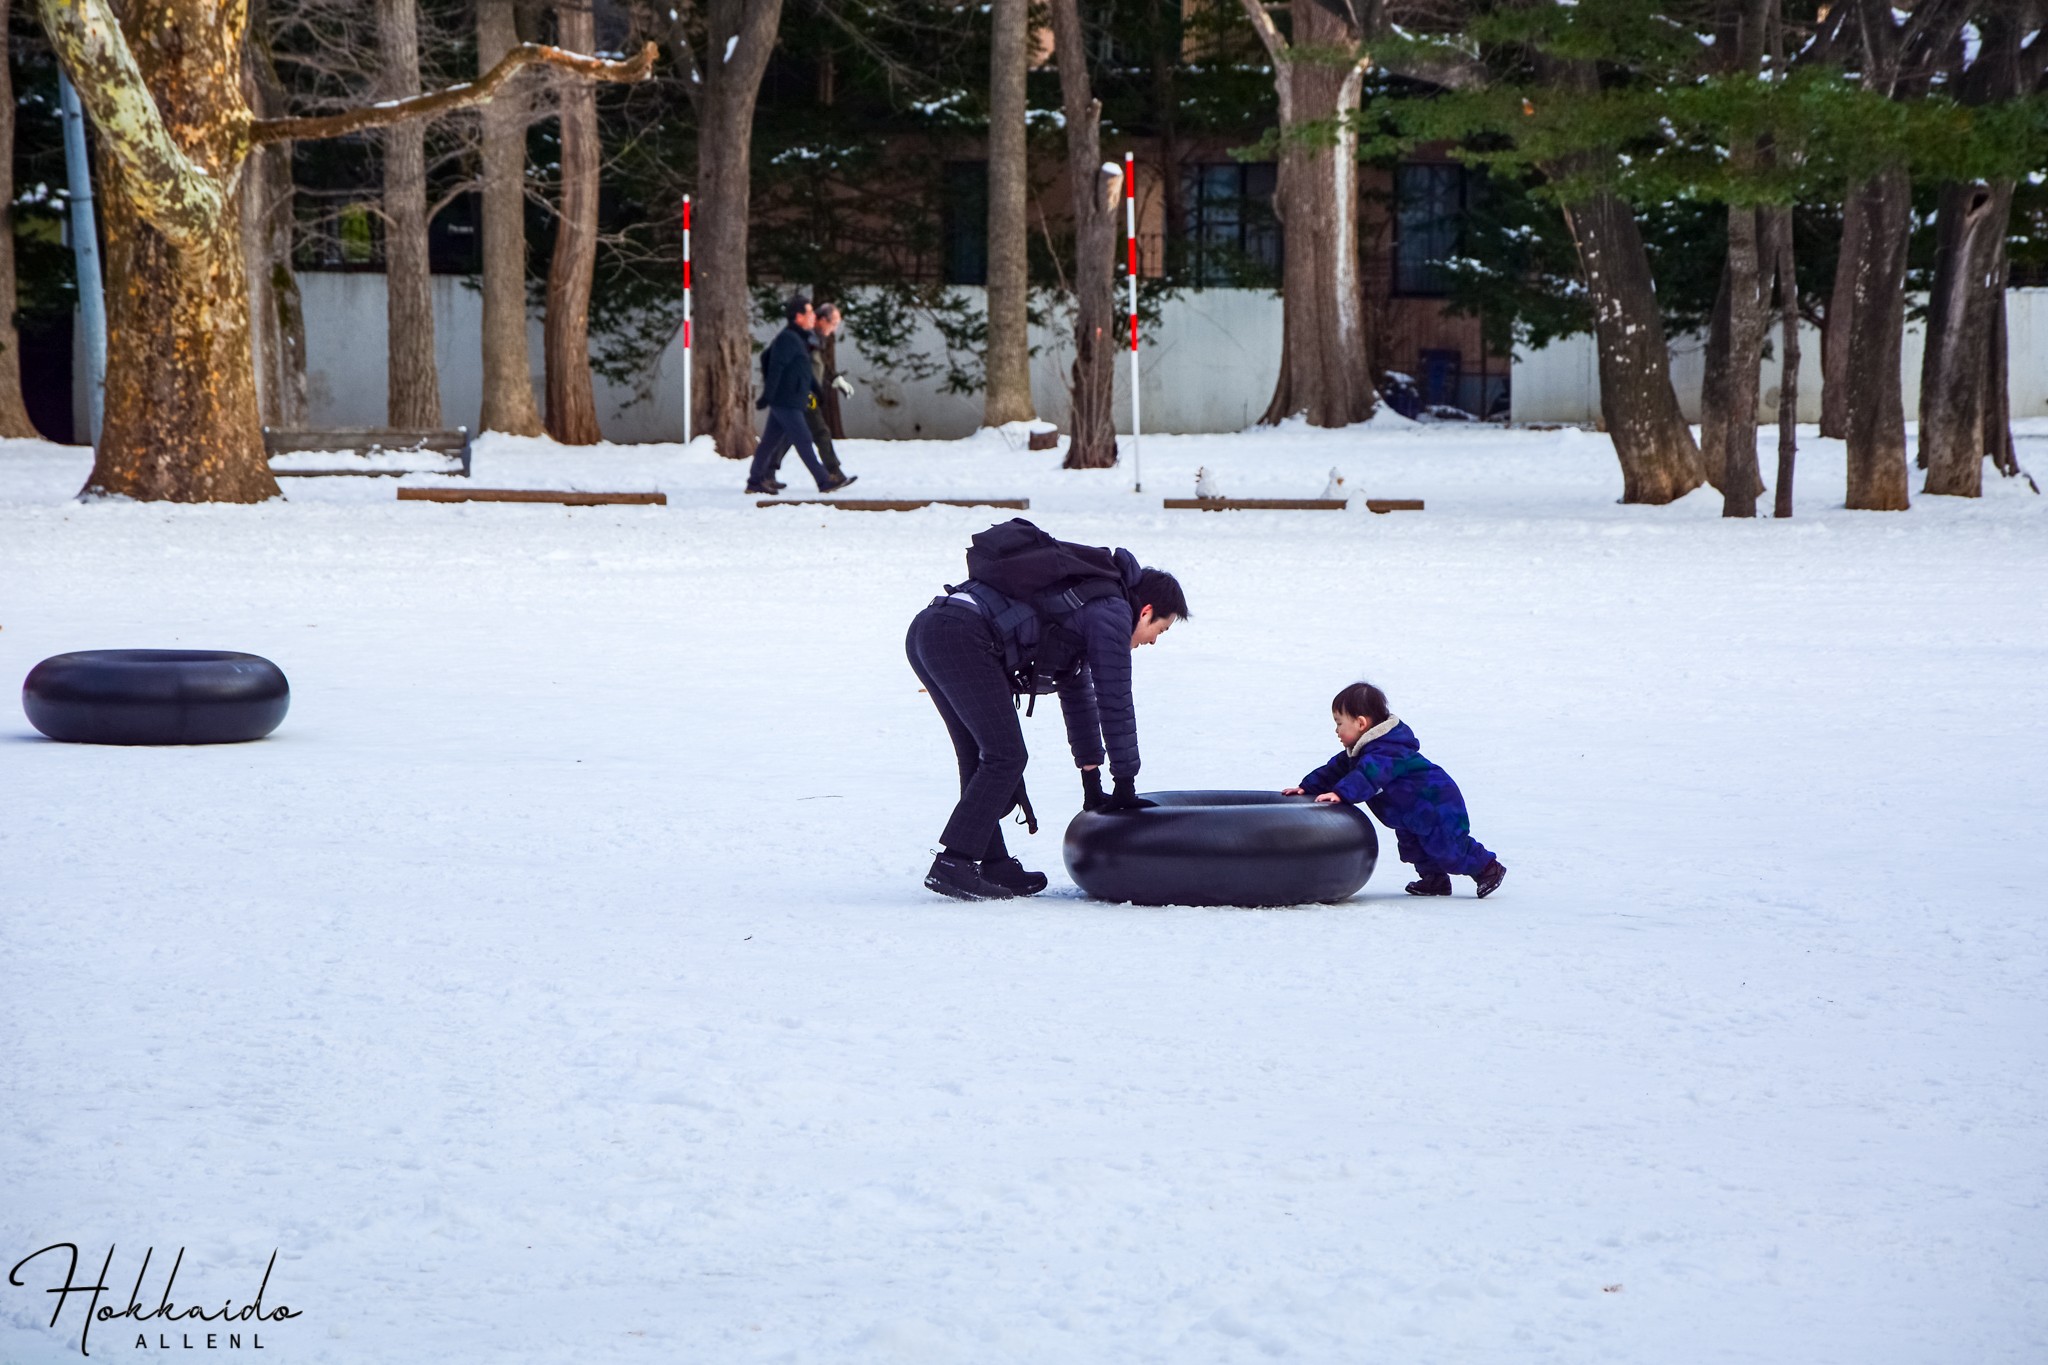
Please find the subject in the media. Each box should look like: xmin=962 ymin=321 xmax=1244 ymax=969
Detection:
xmin=1509 ymin=289 xmax=2048 ymax=424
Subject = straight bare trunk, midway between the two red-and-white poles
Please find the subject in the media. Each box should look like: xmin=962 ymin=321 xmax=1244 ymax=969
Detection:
xmin=981 ymin=0 xmax=1038 ymax=426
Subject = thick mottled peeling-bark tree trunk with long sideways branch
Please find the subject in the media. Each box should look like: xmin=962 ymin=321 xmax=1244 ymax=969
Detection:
xmin=41 ymin=0 xmax=653 ymax=501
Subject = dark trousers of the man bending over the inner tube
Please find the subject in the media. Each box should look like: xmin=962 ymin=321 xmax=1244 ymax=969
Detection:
xmin=903 ymin=600 xmax=1030 ymax=862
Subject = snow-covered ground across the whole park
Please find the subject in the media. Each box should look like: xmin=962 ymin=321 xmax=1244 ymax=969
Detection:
xmin=0 ymin=424 xmax=2048 ymax=1365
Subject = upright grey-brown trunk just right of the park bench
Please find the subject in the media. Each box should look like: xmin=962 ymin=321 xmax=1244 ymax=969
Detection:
xmin=477 ymin=0 xmax=545 ymax=436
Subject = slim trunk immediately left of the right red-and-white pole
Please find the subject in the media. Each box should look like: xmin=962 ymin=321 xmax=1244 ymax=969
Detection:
xmin=1051 ymin=0 xmax=1122 ymax=469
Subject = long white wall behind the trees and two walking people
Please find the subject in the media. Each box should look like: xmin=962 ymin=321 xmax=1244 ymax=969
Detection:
xmin=299 ymin=272 xmax=1280 ymax=440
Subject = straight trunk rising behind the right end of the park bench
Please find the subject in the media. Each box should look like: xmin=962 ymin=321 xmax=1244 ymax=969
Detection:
xmin=377 ymin=0 xmax=448 ymax=430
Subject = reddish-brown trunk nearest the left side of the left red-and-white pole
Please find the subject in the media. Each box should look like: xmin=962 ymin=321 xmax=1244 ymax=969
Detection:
xmin=543 ymin=0 xmax=604 ymax=446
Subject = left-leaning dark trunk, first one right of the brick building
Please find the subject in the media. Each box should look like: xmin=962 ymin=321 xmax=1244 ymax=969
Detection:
xmin=1565 ymin=192 xmax=1703 ymax=503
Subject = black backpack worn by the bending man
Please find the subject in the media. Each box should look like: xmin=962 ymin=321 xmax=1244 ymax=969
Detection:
xmin=946 ymin=518 xmax=1139 ymax=714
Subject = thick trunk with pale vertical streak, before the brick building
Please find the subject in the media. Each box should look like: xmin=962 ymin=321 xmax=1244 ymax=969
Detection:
xmin=1241 ymin=0 xmax=1374 ymax=426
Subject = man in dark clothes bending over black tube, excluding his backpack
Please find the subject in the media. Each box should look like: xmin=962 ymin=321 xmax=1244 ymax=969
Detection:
xmin=903 ymin=551 xmax=1188 ymax=900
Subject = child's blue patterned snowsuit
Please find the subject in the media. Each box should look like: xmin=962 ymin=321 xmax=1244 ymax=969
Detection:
xmin=1300 ymin=716 xmax=1493 ymax=876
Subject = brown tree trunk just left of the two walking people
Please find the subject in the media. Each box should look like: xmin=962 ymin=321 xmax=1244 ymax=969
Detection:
xmin=682 ymin=0 xmax=782 ymax=460
